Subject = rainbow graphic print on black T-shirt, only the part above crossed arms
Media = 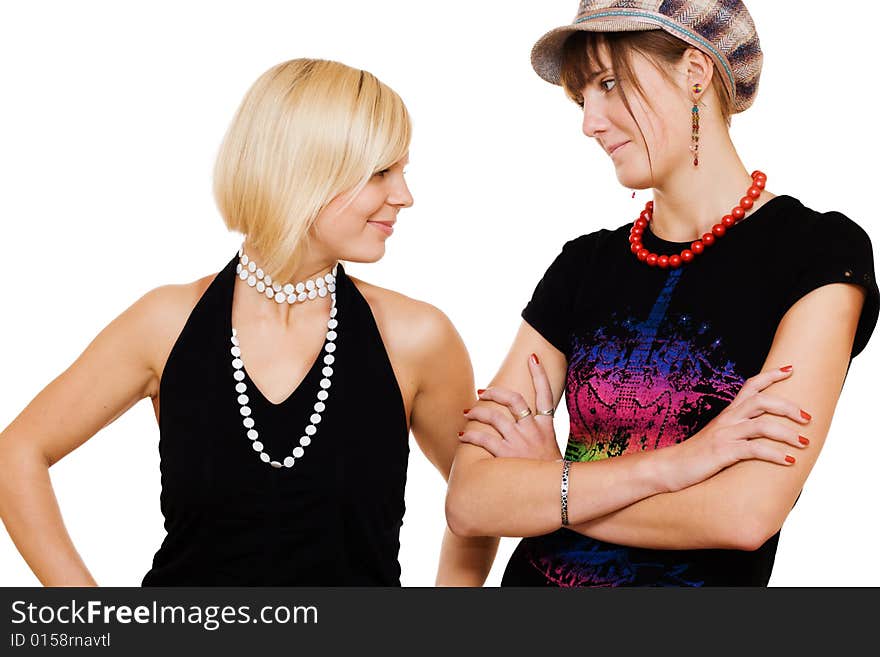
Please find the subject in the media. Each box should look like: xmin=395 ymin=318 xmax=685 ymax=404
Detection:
xmin=566 ymin=270 xmax=745 ymax=461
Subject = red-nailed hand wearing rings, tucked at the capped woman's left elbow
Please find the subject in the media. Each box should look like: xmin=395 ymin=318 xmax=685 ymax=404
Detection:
xmin=459 ymin=354 xmax=562 ymax=461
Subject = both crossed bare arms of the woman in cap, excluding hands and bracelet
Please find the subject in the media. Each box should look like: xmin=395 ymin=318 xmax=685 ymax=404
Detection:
xmin=447 ymin=284 xmax=864 ymax=550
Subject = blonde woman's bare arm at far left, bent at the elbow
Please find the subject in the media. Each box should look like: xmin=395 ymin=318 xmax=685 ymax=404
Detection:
xmin=0 ymin=286 xmax=180 ymax=586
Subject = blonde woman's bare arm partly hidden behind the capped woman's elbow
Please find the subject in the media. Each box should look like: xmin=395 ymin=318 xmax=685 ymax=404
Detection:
xmin=400 ymin=304 xmax=498 ymax=586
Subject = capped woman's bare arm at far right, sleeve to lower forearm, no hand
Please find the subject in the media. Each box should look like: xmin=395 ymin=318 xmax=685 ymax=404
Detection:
xmin=572 ymin=284 xmax=864 ymax=550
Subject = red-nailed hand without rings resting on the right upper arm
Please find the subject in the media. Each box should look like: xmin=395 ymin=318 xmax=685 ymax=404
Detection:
xmin=667 ymin=366 xmax=812 ymax=490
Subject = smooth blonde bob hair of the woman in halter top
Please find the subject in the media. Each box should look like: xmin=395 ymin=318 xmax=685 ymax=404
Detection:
xmin=214 ymin=59 xmax=412 ymax=282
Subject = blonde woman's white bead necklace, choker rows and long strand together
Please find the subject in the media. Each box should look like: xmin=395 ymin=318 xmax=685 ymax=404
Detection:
xmin=230 ymin=249 xmax=339 ymax=468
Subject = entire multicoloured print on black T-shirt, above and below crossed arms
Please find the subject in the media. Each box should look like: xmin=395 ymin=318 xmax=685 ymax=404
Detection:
xmin=528 ymin=270 xmax=745 ymax=586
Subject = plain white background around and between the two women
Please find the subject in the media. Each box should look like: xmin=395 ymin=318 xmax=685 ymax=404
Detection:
xmin=0 ymin=0 xmax=880 ymax=586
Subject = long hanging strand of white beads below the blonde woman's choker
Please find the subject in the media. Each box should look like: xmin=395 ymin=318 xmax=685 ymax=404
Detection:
xmin=230 ymin=250 xmax=339 ymax=468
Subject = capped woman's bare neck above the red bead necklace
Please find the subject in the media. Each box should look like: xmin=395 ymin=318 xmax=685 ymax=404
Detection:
xmin=651 ymin=130 xmax=760 ymax=242
